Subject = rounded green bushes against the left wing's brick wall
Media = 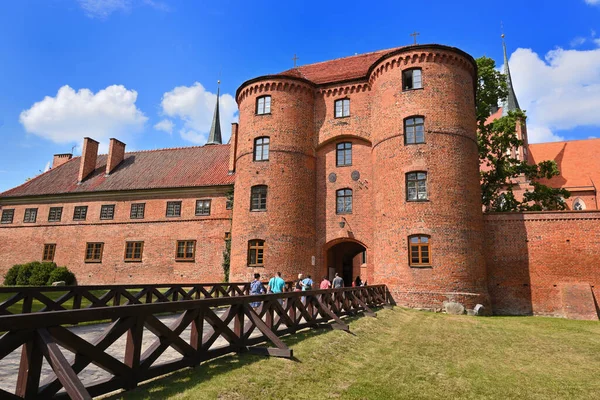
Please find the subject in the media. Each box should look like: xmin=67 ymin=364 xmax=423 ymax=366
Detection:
xmin=4 ymin=261 xmax=76 ymax=286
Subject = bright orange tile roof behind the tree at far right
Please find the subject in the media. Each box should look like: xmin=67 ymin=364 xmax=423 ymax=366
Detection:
xmin=528 ymin=139 xmax=600 ymax=189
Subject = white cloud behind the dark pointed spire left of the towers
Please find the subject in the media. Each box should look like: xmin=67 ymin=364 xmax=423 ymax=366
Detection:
xmin=161 ymin=82 xmax=237 ymax=144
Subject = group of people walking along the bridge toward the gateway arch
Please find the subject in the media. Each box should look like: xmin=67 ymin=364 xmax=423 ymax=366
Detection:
xmin=250 ymin=272 xmax=367 ymax=308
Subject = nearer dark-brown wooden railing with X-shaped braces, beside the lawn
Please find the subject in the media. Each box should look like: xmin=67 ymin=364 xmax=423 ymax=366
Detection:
xmin=0 ymin=285 xmax=390 ymax=399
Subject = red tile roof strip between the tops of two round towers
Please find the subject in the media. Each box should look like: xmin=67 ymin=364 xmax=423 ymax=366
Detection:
xmin=277 ymin=46 xmax=410 ymax=85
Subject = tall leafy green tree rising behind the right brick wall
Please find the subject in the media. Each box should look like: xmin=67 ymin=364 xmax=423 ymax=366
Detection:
xmin=476 ymin=57 xmax=570 ymax=212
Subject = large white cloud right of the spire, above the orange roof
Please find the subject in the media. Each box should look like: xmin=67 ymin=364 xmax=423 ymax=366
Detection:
xmin=509 ymin=46 xmax=600 ymax=143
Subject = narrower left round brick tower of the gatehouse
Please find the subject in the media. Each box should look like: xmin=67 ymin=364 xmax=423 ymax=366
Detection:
xmin=230 ymin=76 xmax=316 ymax=281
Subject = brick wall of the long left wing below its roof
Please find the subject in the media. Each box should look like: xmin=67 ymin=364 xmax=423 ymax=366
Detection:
xmin=0 ymin=193 xmax=231 ymax=284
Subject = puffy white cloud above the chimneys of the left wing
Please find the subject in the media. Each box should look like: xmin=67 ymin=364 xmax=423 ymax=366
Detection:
xmin=19 ymin=85 xmax=147 ymax=149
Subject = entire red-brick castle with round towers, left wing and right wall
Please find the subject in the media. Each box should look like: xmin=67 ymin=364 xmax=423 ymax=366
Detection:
xmin=0 ymin=45 xmax=600 ymax=318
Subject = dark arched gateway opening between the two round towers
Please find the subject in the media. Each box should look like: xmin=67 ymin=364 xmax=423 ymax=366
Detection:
xmin=326 ymin=238 xmax=367 ymax=286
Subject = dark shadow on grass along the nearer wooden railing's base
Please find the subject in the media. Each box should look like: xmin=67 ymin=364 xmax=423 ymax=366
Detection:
xmin=103 ymin=313 xmax=368 ymax=400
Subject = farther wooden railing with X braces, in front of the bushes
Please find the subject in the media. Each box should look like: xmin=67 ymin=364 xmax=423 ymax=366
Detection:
xmin=0 ymin=282 xmax=292 ymax=315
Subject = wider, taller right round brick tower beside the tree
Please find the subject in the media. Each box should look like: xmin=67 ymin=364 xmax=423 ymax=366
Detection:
xmin=369 ymin=45 xmax=489 ymax=308
